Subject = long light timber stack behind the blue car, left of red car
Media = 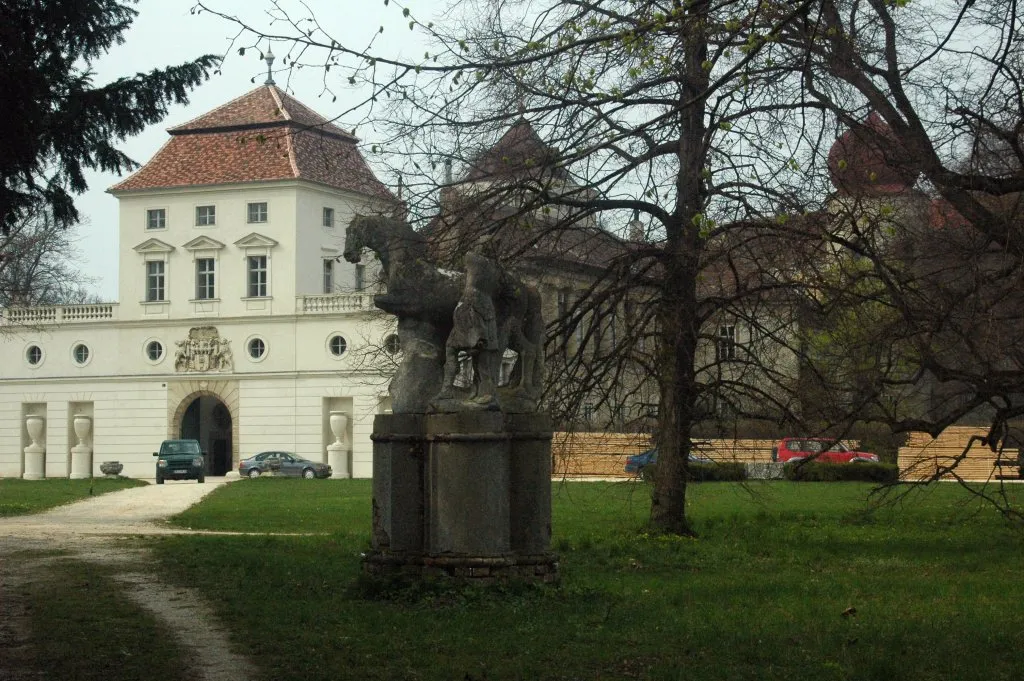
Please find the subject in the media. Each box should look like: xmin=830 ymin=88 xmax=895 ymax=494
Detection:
xmin=551 ymin=432 xmax=775 ymax=477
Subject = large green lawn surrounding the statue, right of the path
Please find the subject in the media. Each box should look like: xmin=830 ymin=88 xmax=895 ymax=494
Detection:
xmin=152 ymin=479 xmax=1024 ymax=681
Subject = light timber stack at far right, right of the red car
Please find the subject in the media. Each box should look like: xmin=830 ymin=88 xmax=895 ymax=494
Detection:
xmin=898 ymin=426 xmax=1017 ymax=481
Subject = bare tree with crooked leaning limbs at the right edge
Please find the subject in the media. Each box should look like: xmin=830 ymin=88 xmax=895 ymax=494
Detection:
xmin=779 ymin=0 xmax=1024 ymax=446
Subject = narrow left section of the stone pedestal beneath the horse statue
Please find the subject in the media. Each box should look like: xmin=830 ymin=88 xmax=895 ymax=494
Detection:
xmin=372 ymin=414 xmax=427 ymax=555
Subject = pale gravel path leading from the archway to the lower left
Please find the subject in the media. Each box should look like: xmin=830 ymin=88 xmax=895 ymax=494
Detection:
xmin=0 ymin=478 xmax=257 ymax=681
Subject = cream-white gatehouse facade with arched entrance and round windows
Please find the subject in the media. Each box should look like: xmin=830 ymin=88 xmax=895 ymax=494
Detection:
xmin=0 ymin=125 xmax=389 ymax=478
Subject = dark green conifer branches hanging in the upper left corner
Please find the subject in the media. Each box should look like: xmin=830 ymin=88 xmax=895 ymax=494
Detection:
xmin=0 ymin=0 xmax=218 ymax=232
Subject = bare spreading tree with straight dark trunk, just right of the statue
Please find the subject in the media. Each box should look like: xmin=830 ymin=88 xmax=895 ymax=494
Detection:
xmin=200 ymin=0 xmax=1024 ymax=533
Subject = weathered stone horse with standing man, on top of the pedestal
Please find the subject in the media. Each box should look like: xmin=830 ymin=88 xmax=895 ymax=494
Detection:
xmin=344 ymin=215 xmax=544 ymax=414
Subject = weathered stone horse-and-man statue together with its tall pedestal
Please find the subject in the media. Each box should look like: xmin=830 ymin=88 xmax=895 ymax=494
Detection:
xmin=354 ymin=216 xmax=558 ymax=582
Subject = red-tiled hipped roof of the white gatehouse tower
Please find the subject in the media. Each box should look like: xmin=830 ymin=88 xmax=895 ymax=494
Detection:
xmin=111 ymin=85 xmax=395 ymax=201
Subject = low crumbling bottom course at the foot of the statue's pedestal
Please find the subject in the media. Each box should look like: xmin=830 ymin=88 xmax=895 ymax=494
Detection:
xmin=362 ymin=551 xmax=558 ymax=585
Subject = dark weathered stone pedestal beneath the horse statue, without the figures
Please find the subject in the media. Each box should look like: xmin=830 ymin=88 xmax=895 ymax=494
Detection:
xmin=364 ymin=405 xmax=558 ymax=582
